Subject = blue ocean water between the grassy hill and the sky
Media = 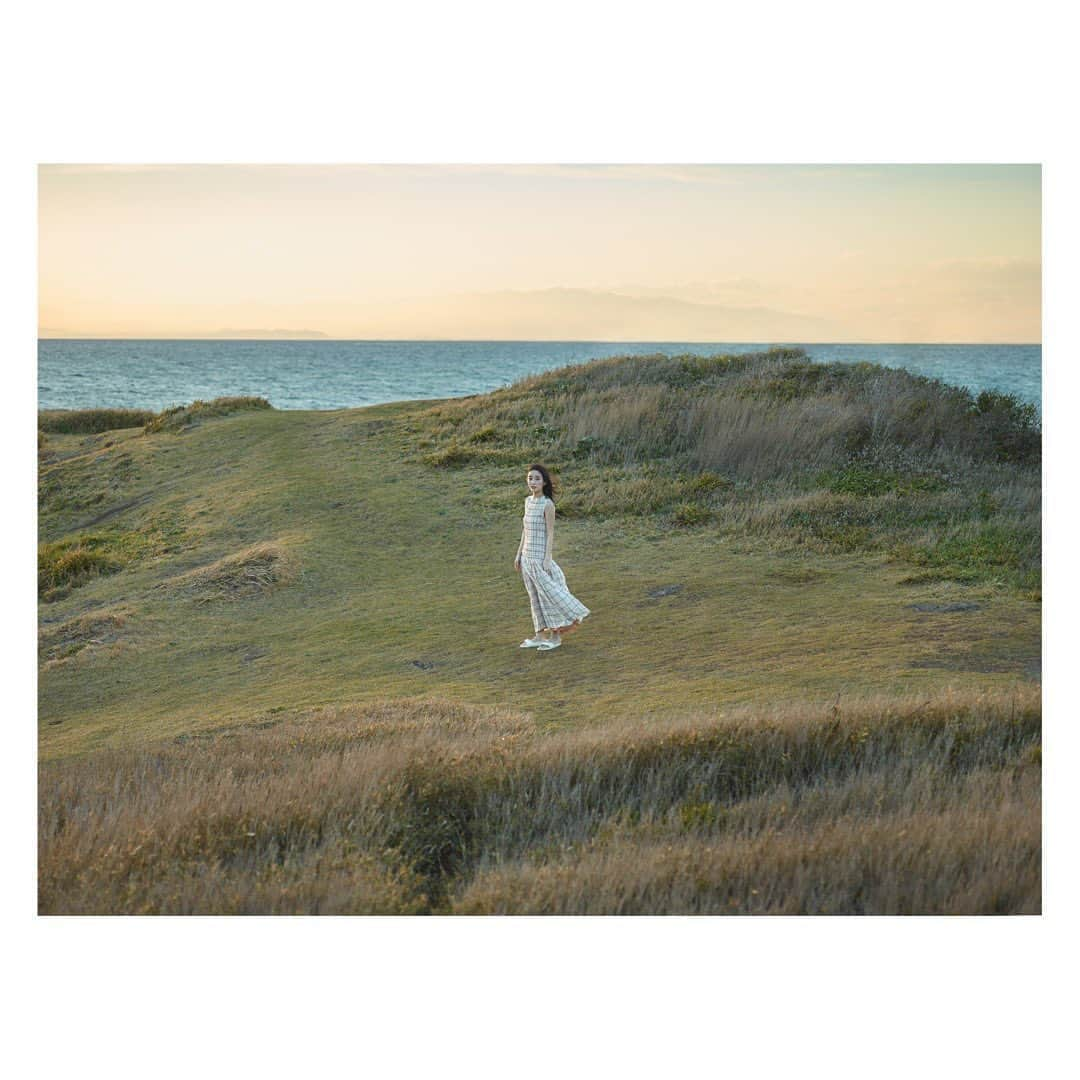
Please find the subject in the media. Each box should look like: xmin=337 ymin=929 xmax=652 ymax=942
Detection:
xmin=38 ymin=339 xmax=1042 ymax=410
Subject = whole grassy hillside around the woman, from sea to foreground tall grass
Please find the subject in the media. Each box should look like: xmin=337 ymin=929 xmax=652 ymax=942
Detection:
xmin=39 ymin=351 xmax=1040 ymax=758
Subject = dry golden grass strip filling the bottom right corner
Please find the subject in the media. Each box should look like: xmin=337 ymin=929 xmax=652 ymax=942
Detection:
xmin=454 ymin=766 xmax=1040 ymax=915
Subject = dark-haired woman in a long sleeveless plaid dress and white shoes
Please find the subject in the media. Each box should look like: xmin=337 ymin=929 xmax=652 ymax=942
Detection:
xmin=514 ymin=465 xmax=589 ymax=650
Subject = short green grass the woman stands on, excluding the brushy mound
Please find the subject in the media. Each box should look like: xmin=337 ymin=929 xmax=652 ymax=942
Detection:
xmin=39 ymin=360 xmax=1040 ymax=757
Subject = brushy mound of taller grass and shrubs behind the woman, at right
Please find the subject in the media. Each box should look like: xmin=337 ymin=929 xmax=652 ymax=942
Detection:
xmin=411 ymin=349 xmax=1041 ymax=596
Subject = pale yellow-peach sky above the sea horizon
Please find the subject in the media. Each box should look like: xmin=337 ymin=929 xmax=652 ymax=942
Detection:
xmin=38 ymin=164 xmax=1041 ymax=342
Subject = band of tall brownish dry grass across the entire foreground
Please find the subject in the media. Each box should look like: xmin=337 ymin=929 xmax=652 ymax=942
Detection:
xmin=39 ymin=689 xmax=1040 ymax=914
